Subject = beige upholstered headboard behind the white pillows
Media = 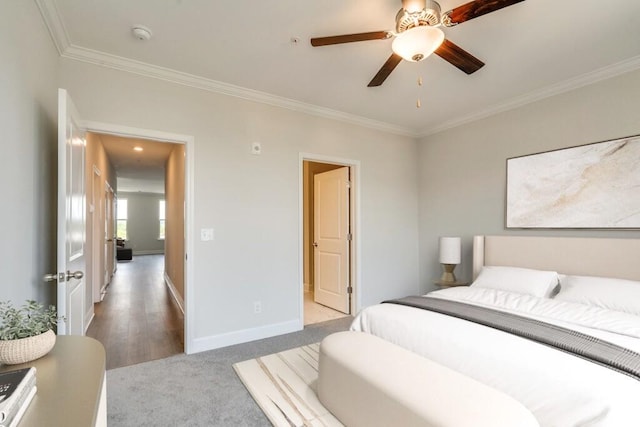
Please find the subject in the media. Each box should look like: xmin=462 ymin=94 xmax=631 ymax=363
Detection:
xmin=473 ymin=236 xmax=640 ymax=280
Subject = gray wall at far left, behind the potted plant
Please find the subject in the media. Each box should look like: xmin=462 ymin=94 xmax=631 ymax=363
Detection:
xmin=0 ymin=1 xmax=58 ymax=304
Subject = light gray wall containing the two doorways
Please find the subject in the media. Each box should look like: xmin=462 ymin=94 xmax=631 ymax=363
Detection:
xmin=60 ymin=59 xmax=418 ymax=351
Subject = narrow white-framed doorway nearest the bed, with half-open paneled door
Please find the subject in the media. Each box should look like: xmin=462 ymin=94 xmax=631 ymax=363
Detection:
xmin=301 ymin=155 xmax=358 ymax=325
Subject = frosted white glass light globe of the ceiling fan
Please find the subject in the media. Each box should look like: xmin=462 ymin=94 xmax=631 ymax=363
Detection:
xmin=391 ymin=25 xmax=444 ymax=62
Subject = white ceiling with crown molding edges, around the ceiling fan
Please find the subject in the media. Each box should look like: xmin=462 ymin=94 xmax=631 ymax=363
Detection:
xmin=36 ymin=0 xmax=640 ymax=136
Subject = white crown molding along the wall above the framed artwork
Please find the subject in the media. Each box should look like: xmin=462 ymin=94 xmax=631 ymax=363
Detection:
xmin=419 ymin=56 xmax=640 ymax=137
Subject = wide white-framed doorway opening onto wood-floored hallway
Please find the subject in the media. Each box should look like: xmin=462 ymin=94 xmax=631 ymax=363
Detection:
xmin=82 ymin=123 xmax=193 ymax=367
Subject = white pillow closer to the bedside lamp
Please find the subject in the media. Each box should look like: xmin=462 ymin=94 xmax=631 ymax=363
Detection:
xmin=471 ymin=266 xmax=558 ymax=298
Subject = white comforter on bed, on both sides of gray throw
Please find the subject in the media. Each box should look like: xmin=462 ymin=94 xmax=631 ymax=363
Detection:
xmin=351 ymin=287 xmax=640 ymax=427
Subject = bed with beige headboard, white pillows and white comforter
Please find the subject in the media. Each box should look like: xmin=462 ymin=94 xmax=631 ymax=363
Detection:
xmin=351 ymin=236 xmax=640 ymax=427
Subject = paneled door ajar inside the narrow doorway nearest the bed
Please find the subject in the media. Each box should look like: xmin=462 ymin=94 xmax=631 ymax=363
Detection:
xmin=313 ymin=167 xmax=350 ymax=314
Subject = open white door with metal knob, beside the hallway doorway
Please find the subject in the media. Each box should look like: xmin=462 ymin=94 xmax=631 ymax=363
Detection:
xmin=57 ymin=89 xmax=86 ymax=335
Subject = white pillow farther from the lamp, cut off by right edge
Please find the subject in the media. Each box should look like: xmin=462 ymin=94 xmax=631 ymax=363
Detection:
xmin=554 ymin=275 xmax=640 ymax=316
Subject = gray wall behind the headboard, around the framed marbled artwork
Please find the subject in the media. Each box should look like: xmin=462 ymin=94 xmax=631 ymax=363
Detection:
xmin=419 ymin=71 xmax=640 ymax=290
